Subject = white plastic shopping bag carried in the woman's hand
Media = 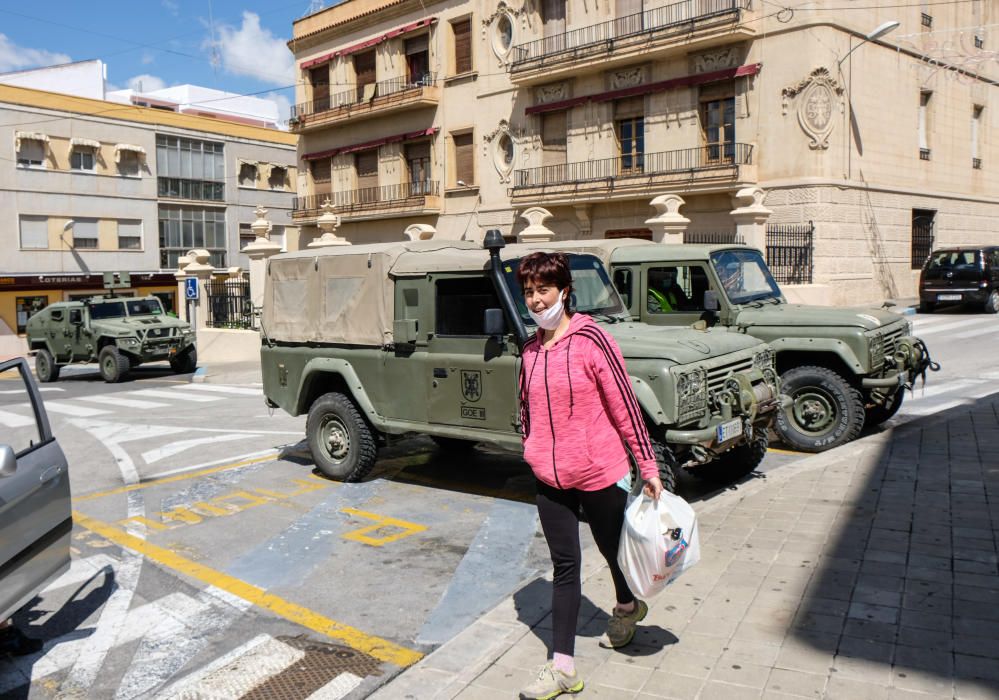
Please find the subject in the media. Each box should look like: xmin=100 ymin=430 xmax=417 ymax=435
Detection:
xmin=617 ymin=480 xmax=701 ymax=598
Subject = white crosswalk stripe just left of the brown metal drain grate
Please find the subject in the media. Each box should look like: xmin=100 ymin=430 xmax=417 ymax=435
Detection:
xmin=159 ymin=638 xmax=305 ymax=700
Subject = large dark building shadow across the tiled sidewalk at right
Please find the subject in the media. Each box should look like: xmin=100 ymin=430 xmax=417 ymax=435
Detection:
xmin=792 ymin=394 xmax=999 ymax=697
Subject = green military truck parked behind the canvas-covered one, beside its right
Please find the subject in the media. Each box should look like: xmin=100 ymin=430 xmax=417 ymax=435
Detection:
xmin=532 ymin=239 xmax=939 ymax=452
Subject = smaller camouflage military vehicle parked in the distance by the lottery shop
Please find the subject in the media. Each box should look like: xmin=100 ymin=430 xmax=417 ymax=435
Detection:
xmin=25 ymin=296 xmax=198 ymax=382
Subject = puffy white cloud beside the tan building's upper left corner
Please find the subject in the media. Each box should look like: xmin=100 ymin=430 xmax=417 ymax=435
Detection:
xmin=215 ymin=12 xmax=295 ymax=85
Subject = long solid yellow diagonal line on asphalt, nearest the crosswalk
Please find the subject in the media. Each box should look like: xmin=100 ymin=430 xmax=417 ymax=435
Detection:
xmin=73 ymin=511 xmax=423 ymax=668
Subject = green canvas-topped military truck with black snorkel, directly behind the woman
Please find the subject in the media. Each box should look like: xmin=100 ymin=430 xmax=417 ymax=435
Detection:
xmin=260 ymin=232 xmax=780 ymax=489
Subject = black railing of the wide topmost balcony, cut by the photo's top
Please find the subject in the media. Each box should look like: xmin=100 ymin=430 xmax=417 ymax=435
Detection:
xmin=512 ymin=0 xmax=749 ymax=70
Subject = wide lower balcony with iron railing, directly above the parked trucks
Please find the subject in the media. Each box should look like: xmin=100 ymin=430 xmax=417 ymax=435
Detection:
xmin=511 ymin=143 xmax=755 ymax=204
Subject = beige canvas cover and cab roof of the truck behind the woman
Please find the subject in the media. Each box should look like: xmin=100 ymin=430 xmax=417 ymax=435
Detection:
xmin=262 ymin=241 xmax=488 ymax=346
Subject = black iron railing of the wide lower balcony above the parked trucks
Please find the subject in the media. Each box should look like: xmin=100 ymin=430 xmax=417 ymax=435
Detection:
xmin=514 ymin=143 xmax=753 ymax=189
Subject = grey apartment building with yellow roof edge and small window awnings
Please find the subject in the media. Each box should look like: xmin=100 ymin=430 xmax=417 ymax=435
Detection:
xmin=0 ymin=84 xmax=298 ymax=355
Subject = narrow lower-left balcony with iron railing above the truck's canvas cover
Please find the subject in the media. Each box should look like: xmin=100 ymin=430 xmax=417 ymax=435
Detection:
xmin=291 ymin=180 xmax=441 ymax=223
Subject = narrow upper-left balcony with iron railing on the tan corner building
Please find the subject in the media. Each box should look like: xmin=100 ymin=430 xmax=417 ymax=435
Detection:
xmin=288 ymin=73 xmax=440 ymax=134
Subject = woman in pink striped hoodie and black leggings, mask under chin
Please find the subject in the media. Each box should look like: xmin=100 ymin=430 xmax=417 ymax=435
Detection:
xmin=517 ymin=253 xmax=663 ymax=700
